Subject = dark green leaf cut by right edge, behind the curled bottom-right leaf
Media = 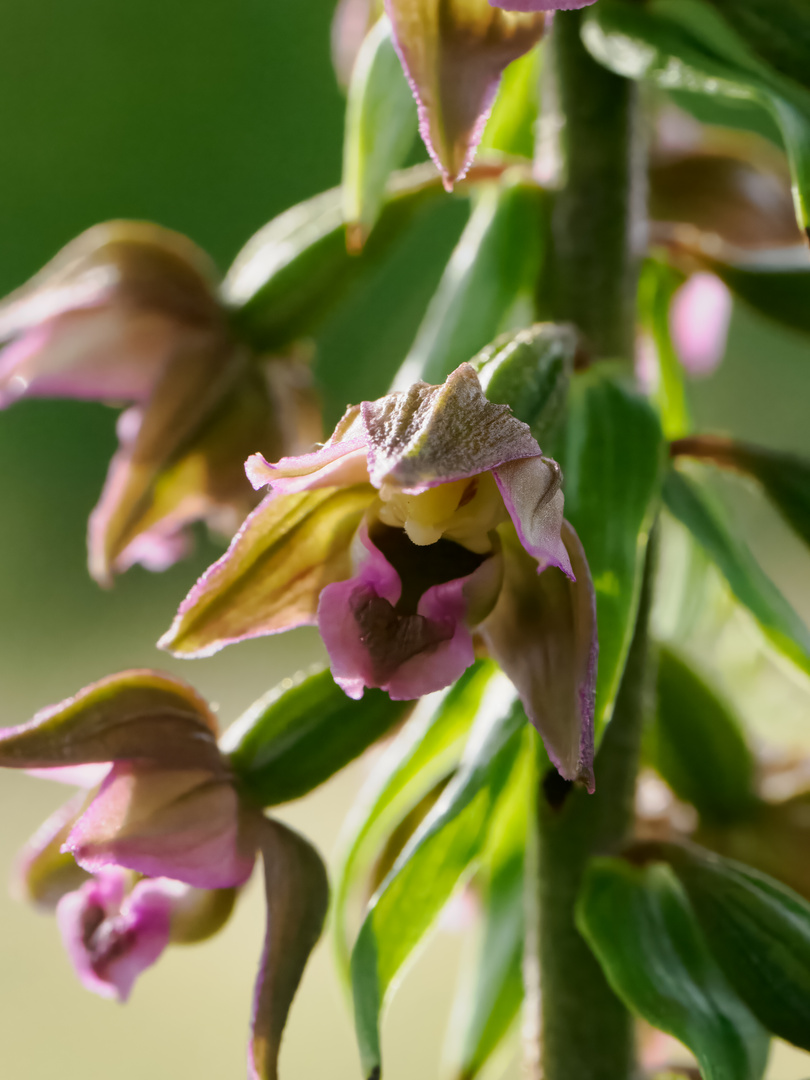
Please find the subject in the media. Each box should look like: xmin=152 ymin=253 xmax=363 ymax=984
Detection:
xmin=662 ymin=845 xmax=810 ymax=1050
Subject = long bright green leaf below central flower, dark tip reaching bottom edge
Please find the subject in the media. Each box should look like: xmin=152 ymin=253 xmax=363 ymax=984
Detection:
xmin=351 ymin=698 xmax=527 ymax=1080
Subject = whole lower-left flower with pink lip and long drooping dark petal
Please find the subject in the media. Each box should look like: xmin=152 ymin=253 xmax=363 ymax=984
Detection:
xmin=0 ymin=671 xmax=327 ymax=1080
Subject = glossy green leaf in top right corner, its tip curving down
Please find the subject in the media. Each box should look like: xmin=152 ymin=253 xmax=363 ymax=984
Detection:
xmin=583 ymin=0 xmax=810 ymax=235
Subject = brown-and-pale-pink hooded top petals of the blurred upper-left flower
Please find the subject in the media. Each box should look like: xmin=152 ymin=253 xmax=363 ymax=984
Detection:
xmin=0 ymin=221 xmax=225 ymax=407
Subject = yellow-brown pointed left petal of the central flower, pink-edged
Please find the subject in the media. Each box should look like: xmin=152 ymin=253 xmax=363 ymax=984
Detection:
xmin=158 ymin=484 xmax=375 ymax=657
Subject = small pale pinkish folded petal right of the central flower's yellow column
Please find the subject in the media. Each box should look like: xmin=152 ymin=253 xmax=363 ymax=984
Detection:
xmin=492 ymin=458 xmax=573 ymax=579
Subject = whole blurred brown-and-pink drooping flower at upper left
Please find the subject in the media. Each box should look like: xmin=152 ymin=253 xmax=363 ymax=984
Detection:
xmin=0 ymin=221 xmax=319 ymax=584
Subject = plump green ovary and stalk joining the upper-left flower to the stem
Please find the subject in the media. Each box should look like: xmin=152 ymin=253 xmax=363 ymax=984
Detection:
xmin=222 ymin=165 xmax=443 ymax=350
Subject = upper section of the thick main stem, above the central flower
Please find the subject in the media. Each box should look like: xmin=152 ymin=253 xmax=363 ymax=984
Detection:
xmin=549 ymin=12 xmax=646 ymax=361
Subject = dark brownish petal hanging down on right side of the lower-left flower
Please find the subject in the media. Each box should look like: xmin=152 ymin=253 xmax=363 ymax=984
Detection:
xmin=247 ymin=819 xmax=329 ymax=1080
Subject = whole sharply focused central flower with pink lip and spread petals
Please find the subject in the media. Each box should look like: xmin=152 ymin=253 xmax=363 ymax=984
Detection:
xmin=160 ymin=364 xmax=596 ymax=784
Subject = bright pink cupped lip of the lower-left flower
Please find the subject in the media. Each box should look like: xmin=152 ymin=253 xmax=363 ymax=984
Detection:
xmin=56 ymin=867 xmax=172 ymax=1001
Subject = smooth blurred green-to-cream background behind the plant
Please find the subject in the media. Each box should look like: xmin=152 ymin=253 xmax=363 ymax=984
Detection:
xmin=0 ymin=0 xmax=810 ymax=1080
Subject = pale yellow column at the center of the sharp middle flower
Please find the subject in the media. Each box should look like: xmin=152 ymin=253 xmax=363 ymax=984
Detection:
xmin=379 ymin=473 xmax=509 ymax=554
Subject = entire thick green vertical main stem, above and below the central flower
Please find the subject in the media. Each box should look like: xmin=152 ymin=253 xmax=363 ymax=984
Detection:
xmin=527 ymin=12 xmax=652 ymax=1080
